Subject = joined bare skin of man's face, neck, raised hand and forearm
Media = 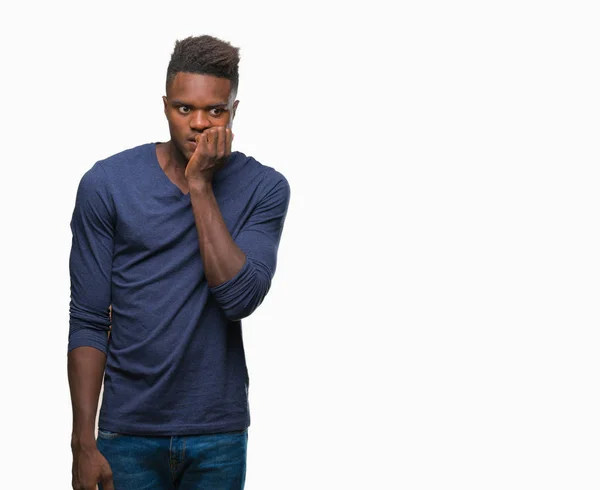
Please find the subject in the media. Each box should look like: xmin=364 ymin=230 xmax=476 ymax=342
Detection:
xmin=157 ymin=73 xmax=246 ymax=287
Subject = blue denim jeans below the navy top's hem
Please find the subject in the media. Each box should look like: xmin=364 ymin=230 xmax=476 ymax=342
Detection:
xmin=97 ymin=429 xmax=248 ymax=490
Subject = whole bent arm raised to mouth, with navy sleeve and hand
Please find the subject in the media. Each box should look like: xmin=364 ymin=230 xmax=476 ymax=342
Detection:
xmin=186 ymin=128 xmax=290 ymax=320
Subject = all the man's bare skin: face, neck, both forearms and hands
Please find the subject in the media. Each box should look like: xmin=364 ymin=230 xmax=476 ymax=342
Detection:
xmin=68 ymin=73 xmax=246 ymax=490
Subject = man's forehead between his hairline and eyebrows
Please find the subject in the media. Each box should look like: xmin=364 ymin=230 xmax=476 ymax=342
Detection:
xmin=167 ymin=72 xmax=231 ymax=104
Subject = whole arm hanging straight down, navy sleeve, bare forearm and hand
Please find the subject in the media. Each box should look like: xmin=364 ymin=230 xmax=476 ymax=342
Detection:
xmin=68 ymin=164 xmax=114 ymax=490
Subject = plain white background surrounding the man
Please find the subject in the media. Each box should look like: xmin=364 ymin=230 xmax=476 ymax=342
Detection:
xmin=0 ymin=0 xmax=600 ymax=490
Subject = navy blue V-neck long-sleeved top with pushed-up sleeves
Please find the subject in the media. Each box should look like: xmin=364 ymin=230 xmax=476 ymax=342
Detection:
xmin=68 ymin=143 xmax=290 ymax=435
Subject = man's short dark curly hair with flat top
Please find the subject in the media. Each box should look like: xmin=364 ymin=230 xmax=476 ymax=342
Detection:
xmin=166 ymin=35 xmax=240 ymax=93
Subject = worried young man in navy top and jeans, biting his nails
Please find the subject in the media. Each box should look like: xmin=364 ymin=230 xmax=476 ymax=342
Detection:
xmin=68 ymin=36 xmax=290 ymax=490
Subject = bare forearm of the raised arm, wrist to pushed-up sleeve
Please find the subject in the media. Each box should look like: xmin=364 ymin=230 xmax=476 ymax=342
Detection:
xmin=190 ymin=183 xmax=246 ymax=287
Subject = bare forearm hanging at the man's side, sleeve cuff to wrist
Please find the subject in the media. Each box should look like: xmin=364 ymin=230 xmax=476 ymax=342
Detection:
xmin=68 ymin=346 xmax=106 ymax=448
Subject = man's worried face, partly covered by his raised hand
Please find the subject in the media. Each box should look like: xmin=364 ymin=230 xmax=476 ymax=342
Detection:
xmin=163 ymin=73 xmax=239 ymax=163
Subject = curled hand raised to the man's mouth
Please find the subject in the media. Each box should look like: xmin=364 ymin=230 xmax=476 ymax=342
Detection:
xmin=185 ymin=126 xmax=233 ymax=183
